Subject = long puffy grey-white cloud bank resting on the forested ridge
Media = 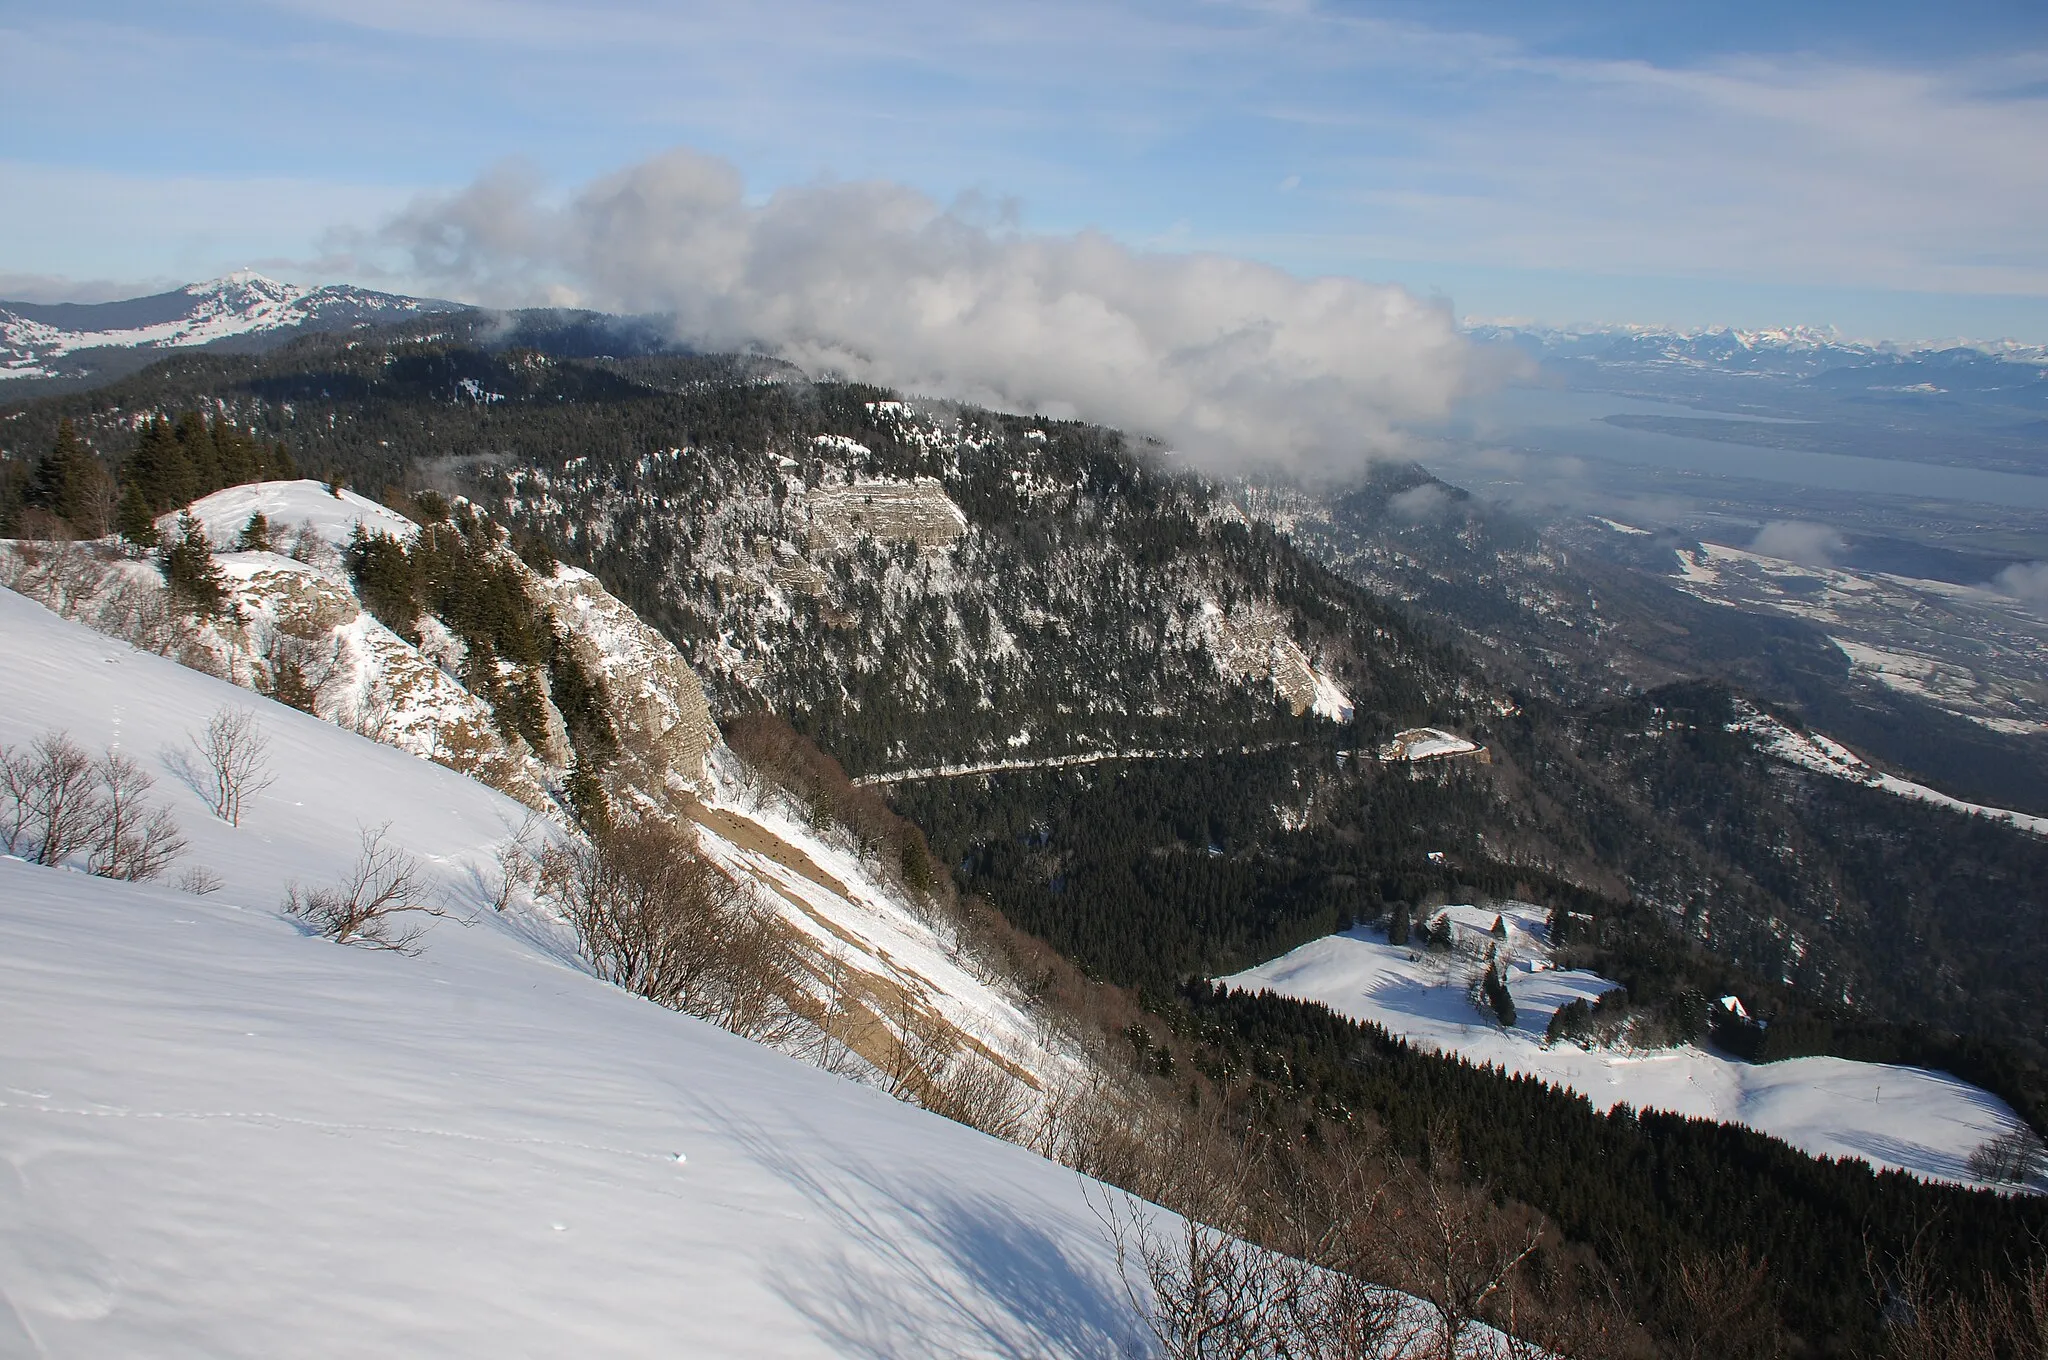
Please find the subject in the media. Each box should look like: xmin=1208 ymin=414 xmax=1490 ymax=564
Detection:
xmin=364 ymin=152 xmax=1470 ymax=475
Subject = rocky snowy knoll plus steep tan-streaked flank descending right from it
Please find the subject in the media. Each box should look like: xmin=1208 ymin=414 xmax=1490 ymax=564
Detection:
xmin=8 ymin=481 xmax=1090 ymax=1118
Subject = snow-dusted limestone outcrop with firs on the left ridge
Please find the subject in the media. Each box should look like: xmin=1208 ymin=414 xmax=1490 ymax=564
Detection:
xmin=0 ymin=481 xmax=719 ymax=815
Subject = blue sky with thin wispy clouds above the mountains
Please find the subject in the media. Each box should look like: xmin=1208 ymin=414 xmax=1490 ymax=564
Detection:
xmin=0 ymin=0 xmax=2048 ymax=342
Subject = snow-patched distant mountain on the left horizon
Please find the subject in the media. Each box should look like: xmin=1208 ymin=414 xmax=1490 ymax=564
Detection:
xmin=0 ymin=270 xmax=461 ymax=379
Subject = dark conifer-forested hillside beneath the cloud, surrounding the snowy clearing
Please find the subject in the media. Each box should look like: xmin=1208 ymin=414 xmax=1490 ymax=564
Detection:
xmin=0 ymin=317 xmax=2048 ymax=1346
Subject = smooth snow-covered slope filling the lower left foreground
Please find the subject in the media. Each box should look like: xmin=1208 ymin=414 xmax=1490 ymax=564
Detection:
xmin=0 ymin=592 xmax=1155 ymax=1356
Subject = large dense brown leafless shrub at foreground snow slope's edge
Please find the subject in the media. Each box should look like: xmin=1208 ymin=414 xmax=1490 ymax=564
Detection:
xmin=537 ymin=825 xmax=803 ymax=1043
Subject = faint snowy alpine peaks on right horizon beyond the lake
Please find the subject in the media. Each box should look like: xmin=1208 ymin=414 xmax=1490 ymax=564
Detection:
xmin=1466 ymin=322 xmax=2048 ymax=377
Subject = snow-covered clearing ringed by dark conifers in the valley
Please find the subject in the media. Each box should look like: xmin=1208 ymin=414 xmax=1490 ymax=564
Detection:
xmin=1221 ymin=903 xmax=2021 ymax=1184
